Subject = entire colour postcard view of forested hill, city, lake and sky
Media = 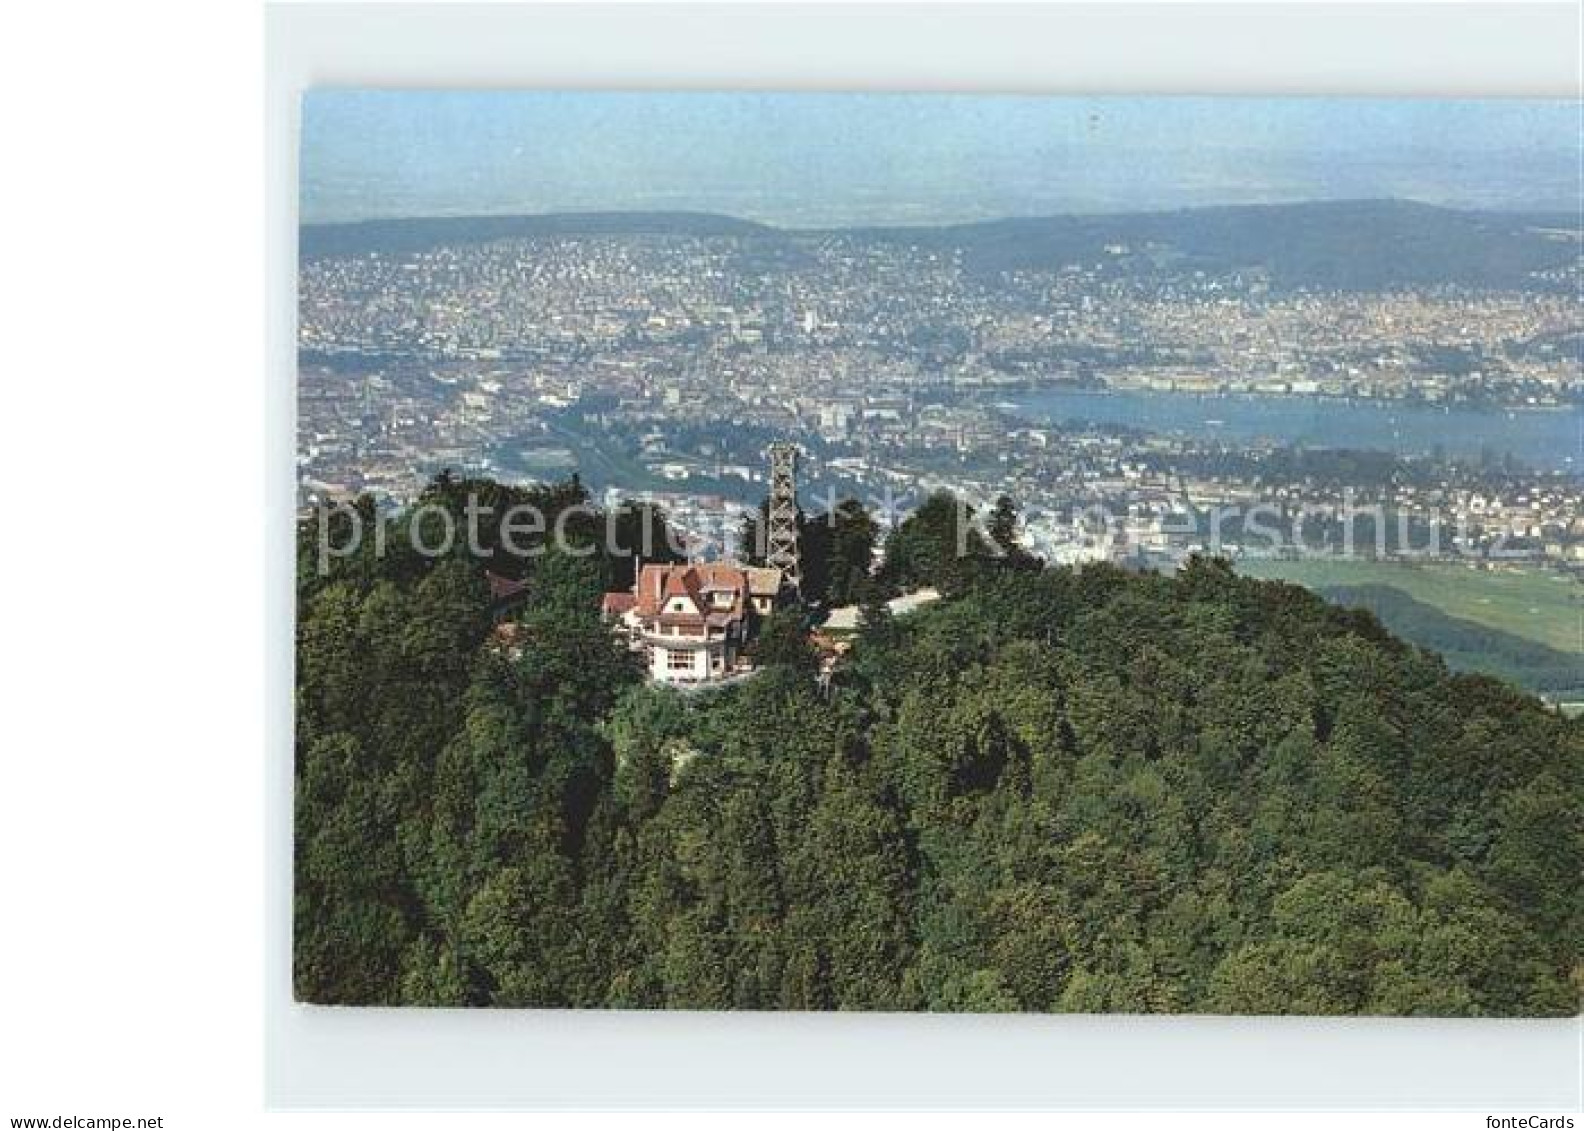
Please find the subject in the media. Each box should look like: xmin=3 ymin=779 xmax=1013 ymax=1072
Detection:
xmin=293 ymin=89 xmax=1584 ymax=1017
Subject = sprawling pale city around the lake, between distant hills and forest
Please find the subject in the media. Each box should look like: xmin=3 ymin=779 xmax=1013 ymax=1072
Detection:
xmin=299 ymin=201 xmax=1584 ymax=566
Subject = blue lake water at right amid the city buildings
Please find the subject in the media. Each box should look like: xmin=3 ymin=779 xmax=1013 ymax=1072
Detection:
xmin=1009 ymin=391 xmax=1584 ymax=474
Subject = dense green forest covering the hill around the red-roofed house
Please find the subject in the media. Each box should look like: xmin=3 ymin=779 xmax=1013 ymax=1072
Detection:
xmin=295 ymin=478 xmax=1584 ymax=1015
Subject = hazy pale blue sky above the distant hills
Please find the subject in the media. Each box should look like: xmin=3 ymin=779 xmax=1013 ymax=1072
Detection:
xmin=301 ymin=90 xmax=1581 ymax=225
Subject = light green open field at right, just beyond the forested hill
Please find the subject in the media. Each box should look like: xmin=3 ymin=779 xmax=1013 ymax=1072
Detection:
xmin=1237 ymin=559 xmax=1584 ymax=656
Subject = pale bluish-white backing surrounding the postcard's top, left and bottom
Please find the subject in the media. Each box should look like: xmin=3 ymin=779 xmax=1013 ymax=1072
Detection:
xmin=265 ymin=3 xmax=1584 ymax=1114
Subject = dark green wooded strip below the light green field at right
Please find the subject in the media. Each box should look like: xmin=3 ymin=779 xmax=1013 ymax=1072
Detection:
xmin=1318 ymin=585 xmax=1584 ymax=691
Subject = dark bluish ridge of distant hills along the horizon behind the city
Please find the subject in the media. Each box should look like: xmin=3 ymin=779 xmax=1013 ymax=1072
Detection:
xmin=299 ymin=200 xmax=1581 ymax=290
